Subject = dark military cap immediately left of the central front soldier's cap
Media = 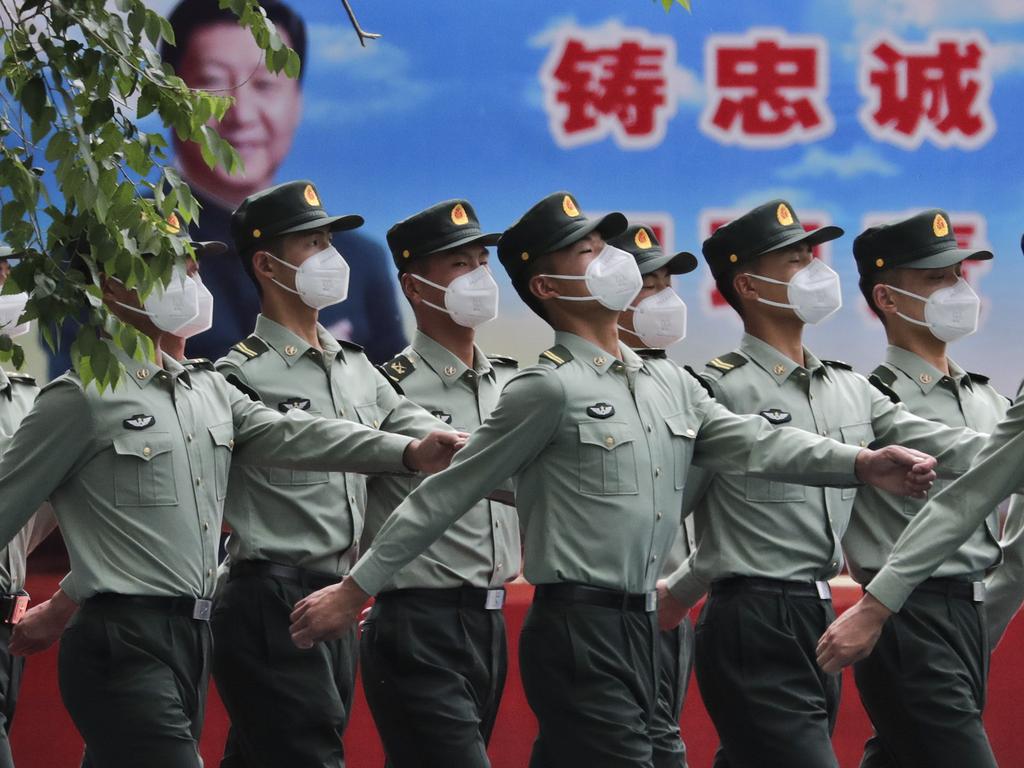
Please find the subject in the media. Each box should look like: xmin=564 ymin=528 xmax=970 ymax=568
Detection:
xmin=387 ymin=200 xmax=501 ymax=270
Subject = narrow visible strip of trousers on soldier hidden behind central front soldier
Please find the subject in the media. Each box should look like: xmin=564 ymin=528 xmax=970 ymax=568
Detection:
xmin=650 ymin=618 xmax=693 ymax=768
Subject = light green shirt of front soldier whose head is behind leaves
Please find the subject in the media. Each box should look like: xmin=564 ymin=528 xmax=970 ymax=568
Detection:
xmin=0 ymin=350 xmax=410 ymax=600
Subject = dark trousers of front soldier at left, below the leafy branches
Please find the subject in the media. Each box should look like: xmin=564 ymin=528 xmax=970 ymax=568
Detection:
xmin=57 ymin=600 xmax=212 ymax=768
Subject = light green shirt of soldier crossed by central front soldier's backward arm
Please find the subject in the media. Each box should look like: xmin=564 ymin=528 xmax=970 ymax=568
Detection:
xmin=364 ymin=331 xmax=520 ymax=590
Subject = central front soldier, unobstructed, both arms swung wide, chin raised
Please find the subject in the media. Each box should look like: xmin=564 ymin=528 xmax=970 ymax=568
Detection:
xmin=292 ymin=193 xmax=933 ymax=768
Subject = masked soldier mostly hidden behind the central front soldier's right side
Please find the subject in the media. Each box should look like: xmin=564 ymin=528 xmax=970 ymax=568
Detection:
xmin=608 ymin=224 xmax=710 ymax=768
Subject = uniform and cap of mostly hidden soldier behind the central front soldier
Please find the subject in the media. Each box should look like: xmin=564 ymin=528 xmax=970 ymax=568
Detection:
xmin=609 ymin=224 xmax=697 ymax=768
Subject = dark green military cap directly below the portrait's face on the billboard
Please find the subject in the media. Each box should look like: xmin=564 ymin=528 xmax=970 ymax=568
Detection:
xmin=231 ymin=179 xmax=362 ymax=254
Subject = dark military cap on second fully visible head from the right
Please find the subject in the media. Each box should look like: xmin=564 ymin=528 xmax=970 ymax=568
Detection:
xmin=702 ymin=200 xmax=843 ymax=279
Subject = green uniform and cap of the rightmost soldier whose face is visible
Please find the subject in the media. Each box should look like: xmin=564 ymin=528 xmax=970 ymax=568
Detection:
xmin=843 ymin=210 xmax=1009 ymax=768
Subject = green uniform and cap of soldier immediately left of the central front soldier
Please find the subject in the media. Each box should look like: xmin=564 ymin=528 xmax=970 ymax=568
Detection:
xmin=359 ymin=200 xmax=520 ymax=768
